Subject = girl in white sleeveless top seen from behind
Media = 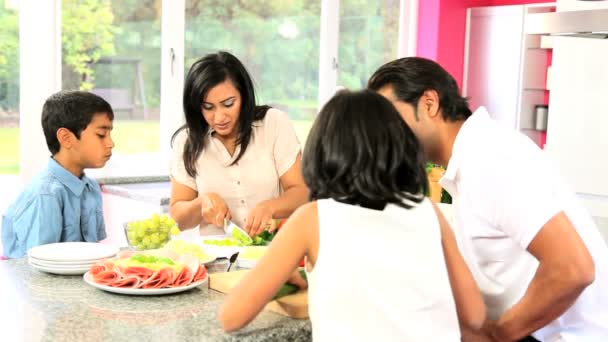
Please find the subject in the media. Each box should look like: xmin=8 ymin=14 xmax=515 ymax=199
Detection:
xmin=219 ymin=91 xmax=485 ymax=341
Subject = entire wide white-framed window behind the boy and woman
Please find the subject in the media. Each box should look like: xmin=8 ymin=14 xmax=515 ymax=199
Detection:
xmin=15 ymin=0 xmax=418 ymax=180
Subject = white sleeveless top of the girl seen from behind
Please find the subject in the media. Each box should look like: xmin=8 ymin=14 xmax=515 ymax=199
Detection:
xmin=308 ymin=199 xmax=460 ymax=341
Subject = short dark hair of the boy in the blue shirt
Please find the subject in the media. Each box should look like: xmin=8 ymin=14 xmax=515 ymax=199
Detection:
xmin=42 ymin=90 xmax=114 ymax=155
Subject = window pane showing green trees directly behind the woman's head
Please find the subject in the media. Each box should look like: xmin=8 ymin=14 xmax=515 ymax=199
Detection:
xmin=185 ymin=0 xmax=321 ymax=144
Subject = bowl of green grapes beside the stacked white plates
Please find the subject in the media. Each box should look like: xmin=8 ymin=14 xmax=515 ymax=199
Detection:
xmin=123 ymin=214 xmax=180 ymax=251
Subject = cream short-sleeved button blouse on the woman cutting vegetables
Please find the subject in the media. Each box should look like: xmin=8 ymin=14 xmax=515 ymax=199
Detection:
xmin=171 ymin=108 xmax=301 ymax=235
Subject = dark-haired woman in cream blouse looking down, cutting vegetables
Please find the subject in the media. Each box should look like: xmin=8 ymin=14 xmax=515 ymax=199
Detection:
xmin=170 ymin=52 xmax=308 ymax=235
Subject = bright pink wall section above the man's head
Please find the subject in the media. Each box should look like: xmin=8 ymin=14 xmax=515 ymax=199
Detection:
xmin=416 ymin=0 xmax=553 ymax=86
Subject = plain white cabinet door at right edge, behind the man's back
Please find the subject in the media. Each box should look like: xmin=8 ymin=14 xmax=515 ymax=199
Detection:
xmin=546 ymin=37 xmax=608 ymax=208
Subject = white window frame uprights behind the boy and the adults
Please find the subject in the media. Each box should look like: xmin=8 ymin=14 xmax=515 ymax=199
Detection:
xmin=19 ymin=0 xmax=419 ymax=181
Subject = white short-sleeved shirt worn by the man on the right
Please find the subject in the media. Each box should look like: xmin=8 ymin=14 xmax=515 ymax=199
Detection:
xmin=439 ymin=107 xmax=608 ymax=341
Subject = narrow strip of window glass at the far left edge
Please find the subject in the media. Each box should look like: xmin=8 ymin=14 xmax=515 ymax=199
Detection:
xmin=0 ymin=0 xmax=19 ymax=174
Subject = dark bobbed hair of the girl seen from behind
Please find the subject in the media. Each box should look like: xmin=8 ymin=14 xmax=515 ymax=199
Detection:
xmin=302 ymin=90 xmax=428 ymax=209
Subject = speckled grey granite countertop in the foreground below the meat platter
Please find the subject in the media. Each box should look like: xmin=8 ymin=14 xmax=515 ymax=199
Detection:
xmin=0 ymin=258 xmax=311 ymax=342
